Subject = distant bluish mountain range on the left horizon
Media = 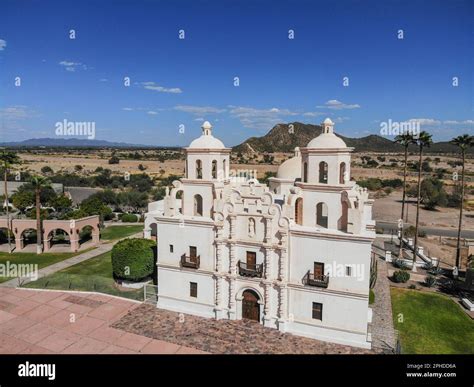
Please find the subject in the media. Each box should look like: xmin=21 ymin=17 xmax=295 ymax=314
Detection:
xmin=0 ymin=138 xmax=149 ymax=148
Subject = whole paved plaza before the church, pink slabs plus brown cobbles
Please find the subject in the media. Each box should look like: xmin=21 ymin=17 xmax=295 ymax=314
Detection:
xmin=0 ymin=287 xmax=382 ymax=354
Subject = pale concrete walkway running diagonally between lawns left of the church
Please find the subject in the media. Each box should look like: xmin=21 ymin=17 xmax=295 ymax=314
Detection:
xmin=0 ymin=233 xmax=142 ymax=288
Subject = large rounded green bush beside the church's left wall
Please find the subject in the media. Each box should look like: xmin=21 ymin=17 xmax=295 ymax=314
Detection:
xmin=112 ymin=238 xmax=156 ymax=281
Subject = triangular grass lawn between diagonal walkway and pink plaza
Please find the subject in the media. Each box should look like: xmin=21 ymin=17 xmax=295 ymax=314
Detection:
xmin=25 ymin=252 xmax=143 ymax=300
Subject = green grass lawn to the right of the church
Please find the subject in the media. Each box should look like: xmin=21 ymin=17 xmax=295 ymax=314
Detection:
xmin=391 ymin=288 xmax=474 ymax=354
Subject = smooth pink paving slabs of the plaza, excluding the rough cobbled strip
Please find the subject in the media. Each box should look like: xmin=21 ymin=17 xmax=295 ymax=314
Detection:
xmin=0 ymin=288 xmax=204 ymax=354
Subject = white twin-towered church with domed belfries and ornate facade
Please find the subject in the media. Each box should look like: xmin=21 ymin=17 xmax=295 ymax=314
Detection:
xmin=144 ymin=119 xmax=375 ymax=348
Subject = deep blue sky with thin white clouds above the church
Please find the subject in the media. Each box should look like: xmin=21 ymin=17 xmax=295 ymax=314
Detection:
xmin=0 ymin=0 xmax=474 ymax=146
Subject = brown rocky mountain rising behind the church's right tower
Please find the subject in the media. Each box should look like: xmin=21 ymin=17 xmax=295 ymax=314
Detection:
xmin=232 ymin=122 xmax=474 ymax=154
